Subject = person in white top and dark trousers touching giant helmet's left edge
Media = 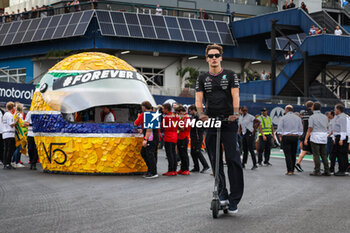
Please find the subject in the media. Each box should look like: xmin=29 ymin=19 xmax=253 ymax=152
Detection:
xmin=24 ymin=111 xmax=38 ymax=170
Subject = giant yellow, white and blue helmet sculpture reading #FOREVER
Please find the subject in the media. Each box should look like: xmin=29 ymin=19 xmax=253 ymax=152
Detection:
xmin=31 ymin=52 xmax=155 ymax=174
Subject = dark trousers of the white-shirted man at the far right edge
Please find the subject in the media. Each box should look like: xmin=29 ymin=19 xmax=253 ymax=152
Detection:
xmin=331 ymin=135 xmax=349 ymax=172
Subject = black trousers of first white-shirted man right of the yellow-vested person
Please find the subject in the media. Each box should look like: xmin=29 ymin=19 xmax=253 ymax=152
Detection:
xmin=282 ymin=136 xmax=298 ymax=172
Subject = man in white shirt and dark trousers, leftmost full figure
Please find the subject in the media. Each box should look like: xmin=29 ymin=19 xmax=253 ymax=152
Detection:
xmin=2 ymin=102 xmax=18 ymax=170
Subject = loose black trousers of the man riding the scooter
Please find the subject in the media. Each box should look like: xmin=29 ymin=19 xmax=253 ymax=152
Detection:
xmin=205 ymin=122 xmax=244 ymax=204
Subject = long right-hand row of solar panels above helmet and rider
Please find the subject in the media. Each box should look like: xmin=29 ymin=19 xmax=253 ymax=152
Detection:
xmin=94 ymin=10 xmax=234 ymax=45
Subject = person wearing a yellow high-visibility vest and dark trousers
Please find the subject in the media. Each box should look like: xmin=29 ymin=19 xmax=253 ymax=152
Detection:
xmin=258 ymin=108 xmax=276 ymax=166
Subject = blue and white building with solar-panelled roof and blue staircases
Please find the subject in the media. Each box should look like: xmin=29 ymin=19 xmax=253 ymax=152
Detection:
xmin=0 ymin=0 xmax=350 ymax=110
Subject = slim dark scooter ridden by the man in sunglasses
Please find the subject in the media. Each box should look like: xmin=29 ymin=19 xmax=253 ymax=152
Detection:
xmin=210 ymin=118 xmax=229 ymax=218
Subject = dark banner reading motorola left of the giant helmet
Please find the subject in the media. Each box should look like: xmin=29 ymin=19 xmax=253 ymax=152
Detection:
xmin=0 ymin=82 xmax=35 ymax=105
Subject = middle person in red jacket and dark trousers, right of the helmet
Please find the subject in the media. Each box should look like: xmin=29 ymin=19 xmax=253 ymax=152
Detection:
xmin=162 ymin=103 xmax=179 ymax=176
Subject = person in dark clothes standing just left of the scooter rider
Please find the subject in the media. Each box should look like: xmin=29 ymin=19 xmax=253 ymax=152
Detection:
xmin=188 ymin=104 xmax=209 ymax=173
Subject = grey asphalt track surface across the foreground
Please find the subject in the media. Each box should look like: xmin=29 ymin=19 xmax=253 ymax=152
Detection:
xmin=0 ymin=150 xmax=350 ymax=233
